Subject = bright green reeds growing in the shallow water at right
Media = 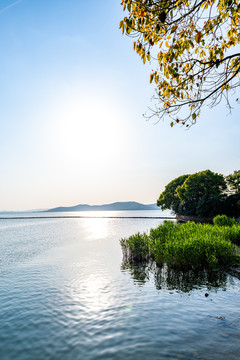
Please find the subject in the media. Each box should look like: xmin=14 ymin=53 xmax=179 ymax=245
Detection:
xmin=120 ymin=215 xmax=240 ymax=271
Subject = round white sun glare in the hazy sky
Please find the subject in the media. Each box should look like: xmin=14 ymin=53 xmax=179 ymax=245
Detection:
xmin=50 ymin=93 xmax=120 ymax=165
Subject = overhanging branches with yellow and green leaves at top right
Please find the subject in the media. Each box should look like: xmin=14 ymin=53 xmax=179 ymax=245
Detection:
xmin=120 ymin=0 xmax=240 ymax=126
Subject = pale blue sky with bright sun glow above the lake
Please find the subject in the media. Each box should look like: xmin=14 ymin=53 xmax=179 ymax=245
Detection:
xmin=0 ymin=0 xmax=240 ymax=211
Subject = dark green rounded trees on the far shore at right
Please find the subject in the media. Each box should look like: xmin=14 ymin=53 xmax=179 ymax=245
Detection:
xmin=157 ymin=170 xmax=240 ymax=217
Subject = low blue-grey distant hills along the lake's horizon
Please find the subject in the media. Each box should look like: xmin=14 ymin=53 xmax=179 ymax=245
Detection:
xmin=46 ymin=201 xmax=160 ymax=212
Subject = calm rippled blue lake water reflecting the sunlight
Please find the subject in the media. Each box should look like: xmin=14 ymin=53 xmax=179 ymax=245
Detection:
xmin=0 ymin=211 xmax=240 ymax=360
